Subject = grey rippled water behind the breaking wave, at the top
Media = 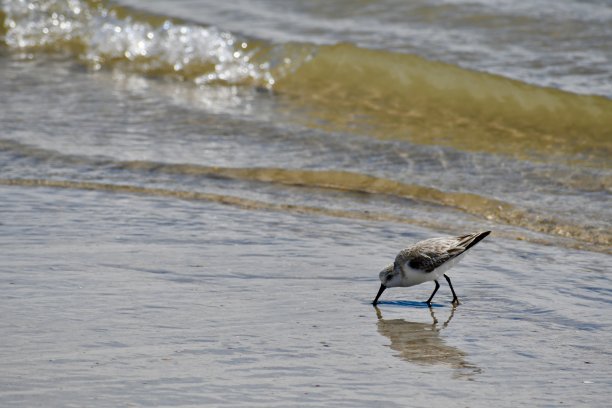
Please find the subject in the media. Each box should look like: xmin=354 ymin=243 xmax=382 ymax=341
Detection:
xmin=119 ymin=0 xmax=612 ymax=96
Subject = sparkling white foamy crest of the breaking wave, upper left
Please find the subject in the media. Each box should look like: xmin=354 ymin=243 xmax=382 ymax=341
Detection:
xmin=3 ymin=0 xmax=274 ymax=86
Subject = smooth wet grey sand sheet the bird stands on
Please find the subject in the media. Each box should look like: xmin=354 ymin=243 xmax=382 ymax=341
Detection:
xmin=0 ymin=186 xmax=612 ymax=407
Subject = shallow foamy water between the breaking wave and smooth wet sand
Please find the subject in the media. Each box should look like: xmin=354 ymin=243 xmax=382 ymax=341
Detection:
xmin=0 ymin=55 xmax=612 ymax=252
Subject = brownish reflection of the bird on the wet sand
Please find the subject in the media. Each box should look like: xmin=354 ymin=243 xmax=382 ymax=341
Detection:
xmin=375 ymin=307 xmax=480 ymax=377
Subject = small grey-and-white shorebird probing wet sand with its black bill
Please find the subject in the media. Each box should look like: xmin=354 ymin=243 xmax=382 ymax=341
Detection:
xmin=372 ymin=231 xmax=491 ymax=306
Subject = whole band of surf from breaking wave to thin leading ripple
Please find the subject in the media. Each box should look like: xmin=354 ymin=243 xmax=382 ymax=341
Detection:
xmin=0 ymin=0 xmax=612 ymax=252
